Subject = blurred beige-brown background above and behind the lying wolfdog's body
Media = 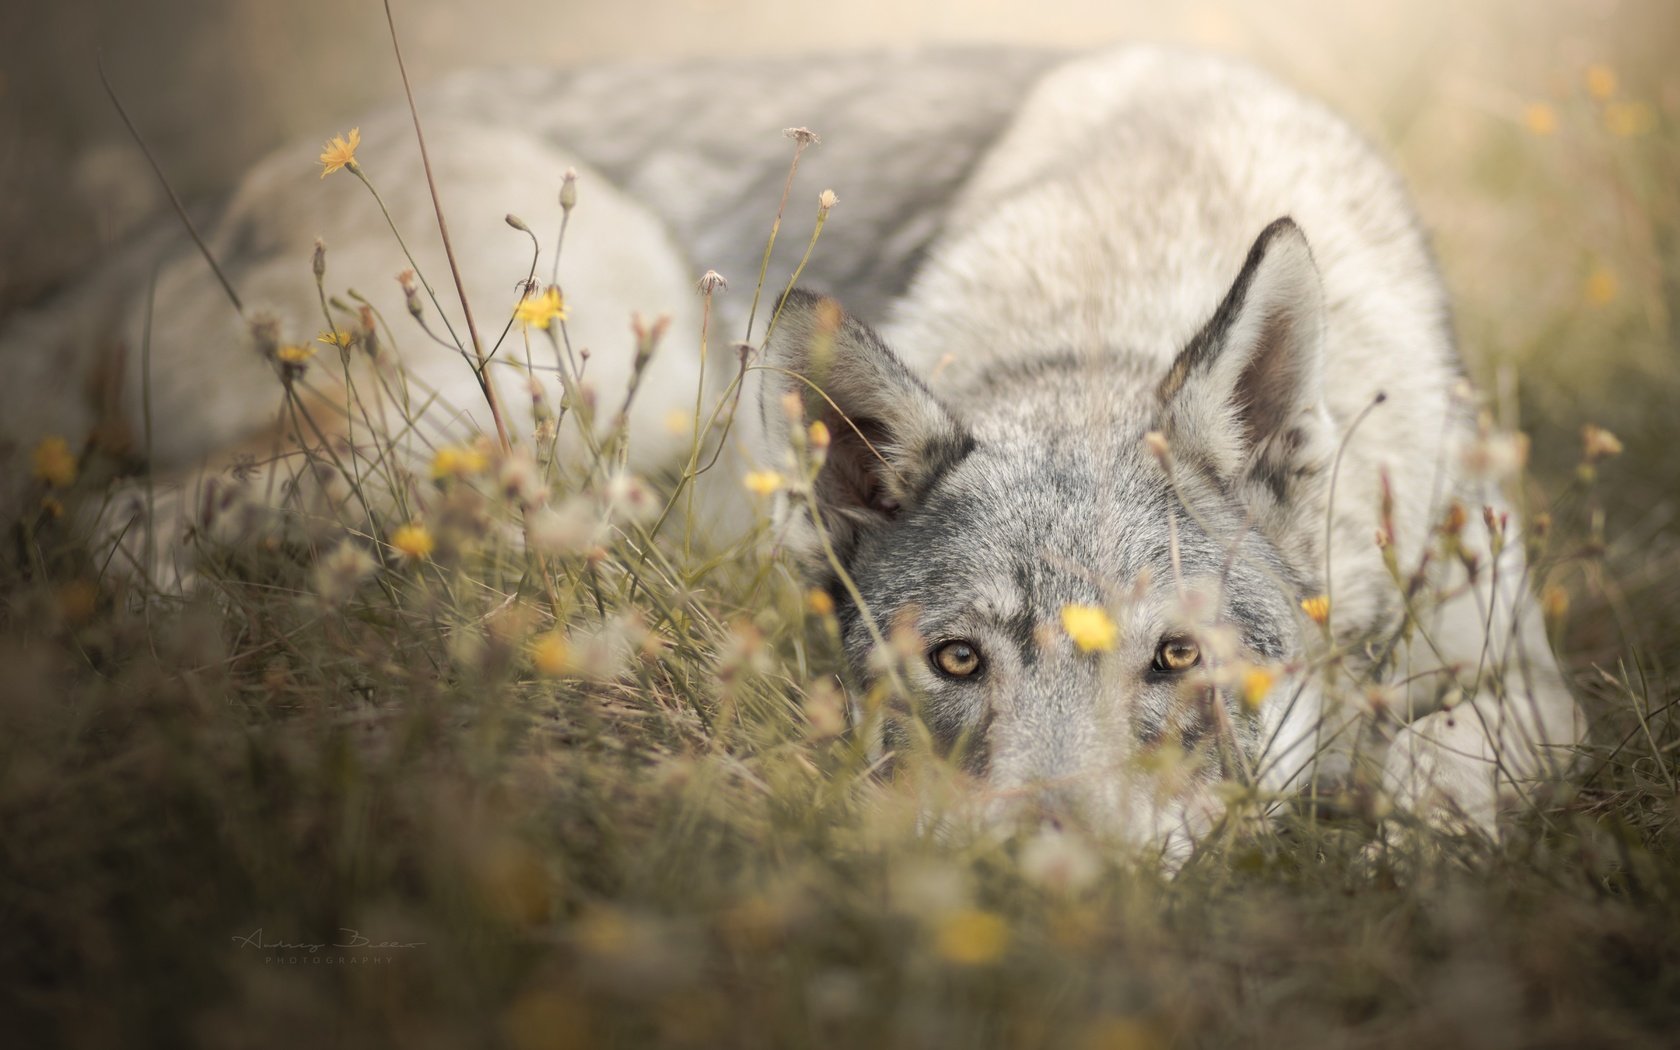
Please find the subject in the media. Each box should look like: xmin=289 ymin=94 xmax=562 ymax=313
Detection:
xmin=0 ymin=0 xmax=1680 ymax=659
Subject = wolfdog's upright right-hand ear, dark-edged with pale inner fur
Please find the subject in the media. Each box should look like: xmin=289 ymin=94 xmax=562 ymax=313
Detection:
xmin=1158 ymin=218 xmax=1334 ymax=567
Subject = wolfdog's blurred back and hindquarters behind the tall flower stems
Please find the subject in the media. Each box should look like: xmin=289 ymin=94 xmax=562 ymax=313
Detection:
xmin=0 ymin=49 xmax=1057 ymax=514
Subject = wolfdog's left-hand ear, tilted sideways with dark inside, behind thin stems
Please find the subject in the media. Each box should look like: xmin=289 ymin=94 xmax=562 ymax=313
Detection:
xmin=759 ymin=289 xmax=973 ymax=566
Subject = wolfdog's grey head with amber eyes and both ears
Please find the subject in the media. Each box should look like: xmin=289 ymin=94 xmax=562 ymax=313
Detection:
xmin=761 ymin=218 xmax=1334 ymax=843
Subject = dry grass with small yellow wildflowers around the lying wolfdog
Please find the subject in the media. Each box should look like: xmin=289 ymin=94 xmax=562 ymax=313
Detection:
xmin=0 ymin=18 xmax=1680 ymax=1048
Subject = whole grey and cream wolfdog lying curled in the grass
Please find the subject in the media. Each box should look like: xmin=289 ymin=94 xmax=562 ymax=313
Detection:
xmin=5 ymin=47 xmax=1583 ymax=855
